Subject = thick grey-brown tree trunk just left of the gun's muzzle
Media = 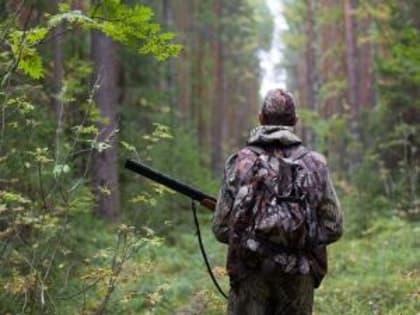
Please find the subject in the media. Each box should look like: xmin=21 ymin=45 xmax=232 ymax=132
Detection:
xmin=92 ymin=32 xmax=119 ymax=220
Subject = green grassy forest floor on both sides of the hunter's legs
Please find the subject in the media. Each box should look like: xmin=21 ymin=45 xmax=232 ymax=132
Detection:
xmin=121 ymin=216 xmax=420 ymax=315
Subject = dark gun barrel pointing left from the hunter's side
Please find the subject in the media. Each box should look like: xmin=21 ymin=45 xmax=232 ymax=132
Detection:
xmin=125 ymin=160 xmax=216 ymax=210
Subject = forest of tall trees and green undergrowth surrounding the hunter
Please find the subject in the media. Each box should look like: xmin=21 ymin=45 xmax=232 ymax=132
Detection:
xmin=0 ymin=0 xmax=420 ymax=315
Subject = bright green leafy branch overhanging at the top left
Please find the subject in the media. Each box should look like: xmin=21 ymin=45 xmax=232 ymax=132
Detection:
xmin=6 ymin=0 xmax=181 ymax=79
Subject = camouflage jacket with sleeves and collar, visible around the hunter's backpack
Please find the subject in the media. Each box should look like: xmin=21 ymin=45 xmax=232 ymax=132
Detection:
xmin=213 ymin=126 xmax=342 ymax=286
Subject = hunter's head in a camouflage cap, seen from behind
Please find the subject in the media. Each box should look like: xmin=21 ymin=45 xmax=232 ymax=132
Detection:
xmin=259 ymin=89 xmax=297 ymax=126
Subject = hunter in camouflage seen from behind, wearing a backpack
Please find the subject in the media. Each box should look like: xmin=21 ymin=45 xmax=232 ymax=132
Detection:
xmin=213 ymin=89 xmax=342 ymax=315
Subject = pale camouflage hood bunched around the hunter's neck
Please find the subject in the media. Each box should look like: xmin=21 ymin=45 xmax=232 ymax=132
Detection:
xmin=248 ymin=125 xmax=302 ymax=146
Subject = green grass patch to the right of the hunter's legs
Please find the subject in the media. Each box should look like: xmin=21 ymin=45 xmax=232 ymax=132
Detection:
xmin=315 ymin=218 xmax=420 ymax=315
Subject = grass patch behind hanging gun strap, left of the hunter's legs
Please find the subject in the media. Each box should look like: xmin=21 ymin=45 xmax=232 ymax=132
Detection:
xmin=115 ymin=221 xmax=228 ymax=315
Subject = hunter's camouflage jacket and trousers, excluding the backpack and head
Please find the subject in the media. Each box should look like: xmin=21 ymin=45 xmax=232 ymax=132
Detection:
xmin=213 ymin=126 xmax=342 ymax=314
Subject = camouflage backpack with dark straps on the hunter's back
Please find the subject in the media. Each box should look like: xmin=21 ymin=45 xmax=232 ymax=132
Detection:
xmin=230 ymin=146 xmax=317 ymax=271
